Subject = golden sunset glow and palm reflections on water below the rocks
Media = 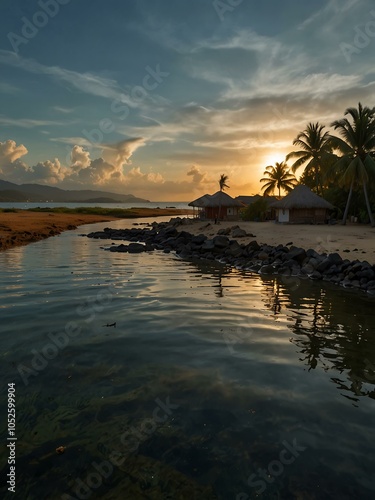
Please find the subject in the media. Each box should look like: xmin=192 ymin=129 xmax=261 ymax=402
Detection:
xmin=181 ymin=261 xmax=375 ymax=404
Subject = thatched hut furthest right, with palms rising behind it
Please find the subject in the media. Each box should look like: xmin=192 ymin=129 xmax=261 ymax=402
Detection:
xmin=271 ymin=185 xmax=334 ymax=224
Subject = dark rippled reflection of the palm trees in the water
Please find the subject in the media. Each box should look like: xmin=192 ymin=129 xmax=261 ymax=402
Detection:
xmin=264 ymin=278 xmax=375 ymax=401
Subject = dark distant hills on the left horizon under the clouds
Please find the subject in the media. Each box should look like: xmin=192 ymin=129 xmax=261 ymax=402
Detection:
xmin=0 ymin=180 xmax=149 ymax=203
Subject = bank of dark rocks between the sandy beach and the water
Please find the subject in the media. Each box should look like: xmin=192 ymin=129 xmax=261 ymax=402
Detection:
xmin=87 ymin=217 xmax=375 ymax=296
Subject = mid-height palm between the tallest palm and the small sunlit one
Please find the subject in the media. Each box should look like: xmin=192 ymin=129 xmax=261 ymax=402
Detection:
xmin=286 ymin=122 xmax=334 ymax=194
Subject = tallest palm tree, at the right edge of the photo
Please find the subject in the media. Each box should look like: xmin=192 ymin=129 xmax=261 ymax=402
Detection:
xmin=331 ymin=103 xmax=375 ymax=227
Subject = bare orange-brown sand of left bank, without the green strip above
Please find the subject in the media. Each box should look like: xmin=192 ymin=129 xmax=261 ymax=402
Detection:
xmin=0 ymin=209 xmax=192 ymax=250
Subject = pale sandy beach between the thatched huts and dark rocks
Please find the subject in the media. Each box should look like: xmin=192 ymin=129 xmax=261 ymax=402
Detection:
xmin=184 ymin=220 xmax=375 ymax=265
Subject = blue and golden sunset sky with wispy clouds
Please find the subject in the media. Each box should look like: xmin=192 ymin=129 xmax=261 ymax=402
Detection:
xmin=0 ymin=0 xmax=375 ymax=201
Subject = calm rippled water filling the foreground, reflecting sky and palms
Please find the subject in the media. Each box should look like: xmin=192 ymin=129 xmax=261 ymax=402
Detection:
xmin=0 ymin=221 xmax=375 ymax=500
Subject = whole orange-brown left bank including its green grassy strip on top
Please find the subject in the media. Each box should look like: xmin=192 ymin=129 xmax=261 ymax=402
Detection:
xmin=0 ymin=207 xmax=193 ymax=251
